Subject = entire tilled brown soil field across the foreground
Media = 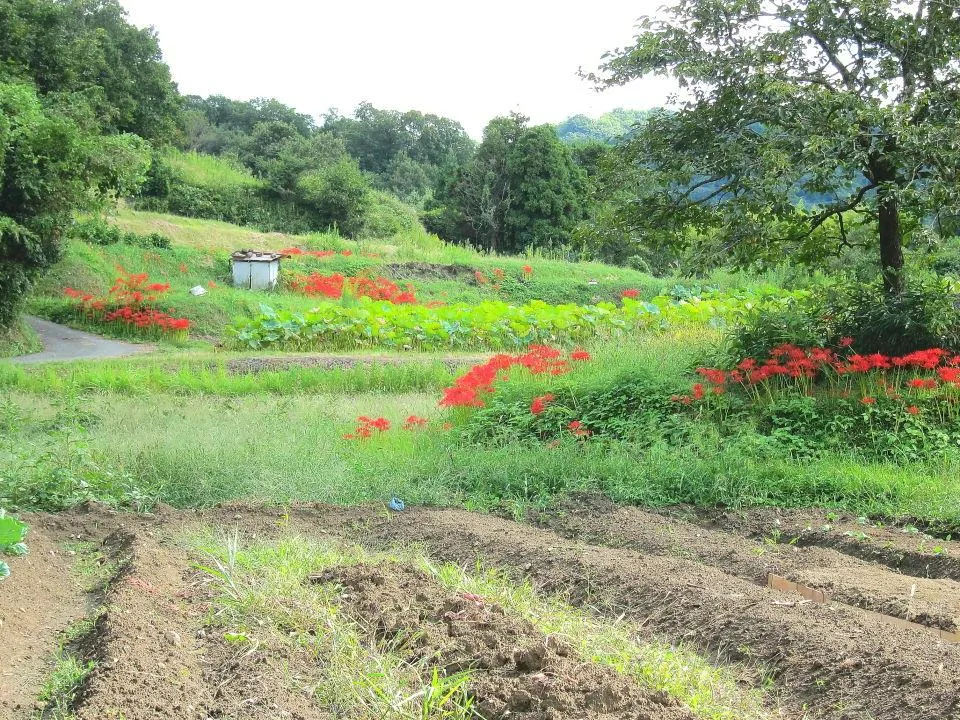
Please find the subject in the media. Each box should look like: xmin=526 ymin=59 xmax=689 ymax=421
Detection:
xmin=0 ymin=500 xmax=960 ymax=720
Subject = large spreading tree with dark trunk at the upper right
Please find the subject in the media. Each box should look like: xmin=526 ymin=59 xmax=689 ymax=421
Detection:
xmin=595 ymin=0 xmax=960 ymax=294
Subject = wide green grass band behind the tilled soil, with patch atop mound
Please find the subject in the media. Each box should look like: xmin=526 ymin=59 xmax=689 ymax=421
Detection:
xmin=0 ymin=330 xmax=960 ymax=527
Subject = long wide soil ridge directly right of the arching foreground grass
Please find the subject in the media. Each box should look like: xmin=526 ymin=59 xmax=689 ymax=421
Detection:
xmin=314 ymin=509 xmax=960 ymax=720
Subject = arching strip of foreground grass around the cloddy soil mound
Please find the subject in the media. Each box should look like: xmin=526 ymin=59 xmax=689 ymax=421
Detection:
xmin=191 ymin=534 xmax=773 ymax=720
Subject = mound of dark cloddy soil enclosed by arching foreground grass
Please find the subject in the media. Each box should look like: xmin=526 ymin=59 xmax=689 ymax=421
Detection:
xmin=326 ymin=565 xmax=694 ymax=720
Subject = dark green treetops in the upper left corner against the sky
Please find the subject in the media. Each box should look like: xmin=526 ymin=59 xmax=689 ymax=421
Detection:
xmin=0 ymin=0 xmax=180 ymax=140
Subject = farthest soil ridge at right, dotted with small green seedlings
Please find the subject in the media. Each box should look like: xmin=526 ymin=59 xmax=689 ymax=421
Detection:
xmin=658 ymin=506 xmax=960 ymax=581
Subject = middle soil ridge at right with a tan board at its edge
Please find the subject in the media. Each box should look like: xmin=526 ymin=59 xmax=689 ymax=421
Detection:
xmin=534 ymin=498 xmax=960 ymax=631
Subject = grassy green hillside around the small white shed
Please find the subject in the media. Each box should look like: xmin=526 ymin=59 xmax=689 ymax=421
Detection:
xmin=22 ymin=208 xmax=776 ymax=340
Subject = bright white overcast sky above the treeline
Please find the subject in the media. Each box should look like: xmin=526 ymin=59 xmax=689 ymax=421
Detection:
xmin=121 ymin=0 xmax=672 ymax=138
